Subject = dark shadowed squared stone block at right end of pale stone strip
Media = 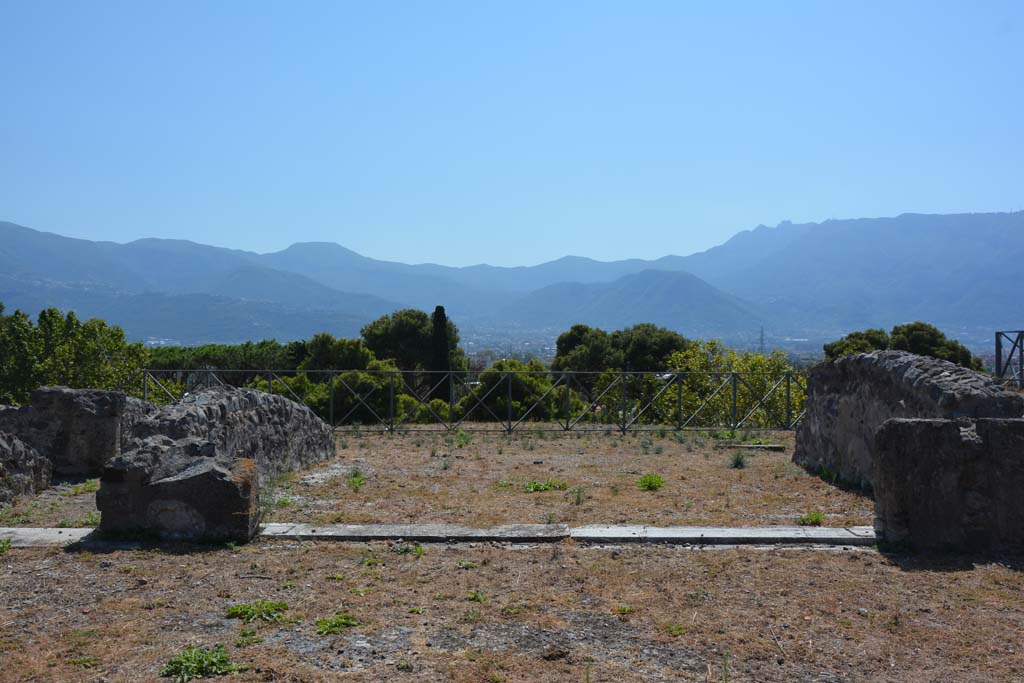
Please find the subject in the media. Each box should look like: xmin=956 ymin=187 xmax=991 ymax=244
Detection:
xmin=873 ymin=419 xmax=1024 ymax=551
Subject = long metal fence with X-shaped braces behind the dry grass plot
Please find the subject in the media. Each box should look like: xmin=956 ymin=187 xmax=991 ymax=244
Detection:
xmin=137 ymin=369 xmax=806 ymax=433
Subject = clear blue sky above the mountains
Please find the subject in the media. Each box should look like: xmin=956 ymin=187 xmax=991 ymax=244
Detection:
xmin=0 ymin=0 xmax=1024 ymax=265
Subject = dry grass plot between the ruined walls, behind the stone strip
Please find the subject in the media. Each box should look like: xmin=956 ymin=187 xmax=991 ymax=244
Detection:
xmin=264 ymin=432 xmax=873 ymax=526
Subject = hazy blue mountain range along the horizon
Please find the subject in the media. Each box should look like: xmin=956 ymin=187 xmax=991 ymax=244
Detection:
xmin=0 ymin=212 xmax=1024 ymax=347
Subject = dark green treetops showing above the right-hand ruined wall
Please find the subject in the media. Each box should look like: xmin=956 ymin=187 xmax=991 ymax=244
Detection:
xmin=824 ymin=321 xmax=982 ymax=370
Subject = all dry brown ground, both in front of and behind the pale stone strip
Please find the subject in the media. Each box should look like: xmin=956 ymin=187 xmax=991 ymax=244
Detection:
xmin=0 ymin=433 xmax=1024 ymax=683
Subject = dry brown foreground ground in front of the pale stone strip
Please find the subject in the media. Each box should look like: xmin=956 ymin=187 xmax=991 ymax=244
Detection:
xmin=0 ymin=541 xmax=1024 ymax=683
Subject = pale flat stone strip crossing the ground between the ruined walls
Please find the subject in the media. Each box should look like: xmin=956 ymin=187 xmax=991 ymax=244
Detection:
xmin=0 ymin=523 xmax=876 ymax=548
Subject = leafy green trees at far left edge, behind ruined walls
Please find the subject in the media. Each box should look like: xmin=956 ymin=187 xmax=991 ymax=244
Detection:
xmin=0 ymin=304 xmax=148 ymax=404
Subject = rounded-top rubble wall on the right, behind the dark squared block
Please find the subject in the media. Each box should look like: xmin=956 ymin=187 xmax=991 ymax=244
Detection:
xmin=793 ymin=351 xmax=1024 ymax=489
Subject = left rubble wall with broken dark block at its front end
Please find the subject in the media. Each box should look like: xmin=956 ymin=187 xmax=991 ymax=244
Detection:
xmin=96 ymin=387 xmax=334 ymax=541
